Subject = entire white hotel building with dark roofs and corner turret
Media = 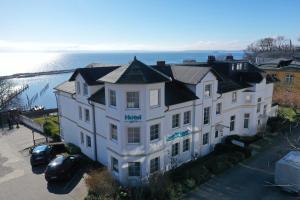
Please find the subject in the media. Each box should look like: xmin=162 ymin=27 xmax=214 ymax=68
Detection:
xmin=55 ymin=56 xmax=273 ymax=184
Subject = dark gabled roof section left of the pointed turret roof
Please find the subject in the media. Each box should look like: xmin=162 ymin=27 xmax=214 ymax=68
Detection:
xmin=69 ymin=64 xmax=120 ymax=85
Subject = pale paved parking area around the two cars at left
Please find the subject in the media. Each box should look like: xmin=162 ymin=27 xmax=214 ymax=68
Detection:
xmin=0 ymin=126 xmax=87 ymax=200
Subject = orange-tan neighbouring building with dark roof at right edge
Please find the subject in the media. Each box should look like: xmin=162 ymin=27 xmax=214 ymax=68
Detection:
xmin=259 ymin=59 xmax=300 ymax=107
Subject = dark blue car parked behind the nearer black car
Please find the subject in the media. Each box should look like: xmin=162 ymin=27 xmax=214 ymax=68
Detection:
xmin=30 ymin=143 xmax=66 ymax=166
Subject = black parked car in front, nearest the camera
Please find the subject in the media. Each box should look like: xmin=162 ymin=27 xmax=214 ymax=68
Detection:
xmin=45 ymin=155 xmax=82 ymax=182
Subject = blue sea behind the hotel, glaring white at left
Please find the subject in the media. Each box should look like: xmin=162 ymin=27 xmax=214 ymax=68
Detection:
xmin=0 ymin=51 xmax=244 ymax=109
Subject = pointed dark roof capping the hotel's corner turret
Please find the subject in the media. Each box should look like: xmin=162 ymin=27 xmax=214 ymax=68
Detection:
xmin=98 ymin=58 xmax=171 ymax=84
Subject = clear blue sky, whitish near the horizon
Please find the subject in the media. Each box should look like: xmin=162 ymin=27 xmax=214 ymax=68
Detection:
xmin=0 ymin=0 xmax=300 ymax=52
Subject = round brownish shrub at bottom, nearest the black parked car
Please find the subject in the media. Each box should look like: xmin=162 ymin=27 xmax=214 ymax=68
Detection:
xmin=85 ymin=169 xmax=118 ymax=199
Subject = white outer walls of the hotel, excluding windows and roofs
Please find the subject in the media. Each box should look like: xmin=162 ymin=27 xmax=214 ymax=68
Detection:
xmin=57 ymin=73 xmax=273 ymax=184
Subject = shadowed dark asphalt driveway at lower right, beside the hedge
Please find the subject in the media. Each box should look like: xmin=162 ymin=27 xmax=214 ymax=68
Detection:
xmin=186 ymin=129 xmax=300 ymax=200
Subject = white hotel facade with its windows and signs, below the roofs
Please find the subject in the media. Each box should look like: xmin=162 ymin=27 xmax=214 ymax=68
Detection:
xmin=56 ymin=59 xmax=273 ymax=184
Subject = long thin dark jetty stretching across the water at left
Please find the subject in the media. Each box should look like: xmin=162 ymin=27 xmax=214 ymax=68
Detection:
xmin=0 ymin=69 xmax=75 ymax=80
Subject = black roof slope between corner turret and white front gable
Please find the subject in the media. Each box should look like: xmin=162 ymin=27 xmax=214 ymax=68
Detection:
xmin=165 ymin=81 xmax=198 ymax=106
